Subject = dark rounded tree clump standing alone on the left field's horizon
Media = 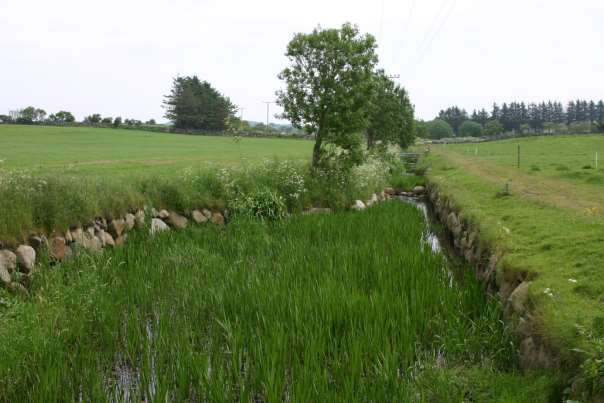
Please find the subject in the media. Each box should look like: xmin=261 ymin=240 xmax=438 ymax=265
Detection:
xmin=164 ymin=76 xmax=236 ymax=131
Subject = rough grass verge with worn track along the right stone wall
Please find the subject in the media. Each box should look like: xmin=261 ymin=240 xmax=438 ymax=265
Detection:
xmin=428 ymin=137 xmax=604 ymax=396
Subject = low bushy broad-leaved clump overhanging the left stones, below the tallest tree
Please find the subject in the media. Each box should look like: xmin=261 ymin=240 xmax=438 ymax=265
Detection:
xmin=231 ymin=188 xmax=286 ymax=221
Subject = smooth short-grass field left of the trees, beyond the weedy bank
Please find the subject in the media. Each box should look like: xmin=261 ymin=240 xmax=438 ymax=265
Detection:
xmin=0 ymin=125 xmax=312 ymax=176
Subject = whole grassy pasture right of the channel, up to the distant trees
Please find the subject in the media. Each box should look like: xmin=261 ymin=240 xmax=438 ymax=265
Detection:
xmin=429 ymin=136 xmax=604 ymax=398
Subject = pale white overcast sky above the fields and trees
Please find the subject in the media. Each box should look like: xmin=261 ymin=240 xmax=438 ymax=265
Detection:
xmin=0 ymin=0 xmax=604 ymax=121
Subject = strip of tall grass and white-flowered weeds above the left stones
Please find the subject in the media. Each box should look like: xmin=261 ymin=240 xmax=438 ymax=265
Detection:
xmin=0 ymin=160 xmax=388 ymax=243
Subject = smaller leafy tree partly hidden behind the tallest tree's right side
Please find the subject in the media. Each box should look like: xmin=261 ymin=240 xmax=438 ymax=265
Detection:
xmin=366 ymin=70 xmax=415 ymax=149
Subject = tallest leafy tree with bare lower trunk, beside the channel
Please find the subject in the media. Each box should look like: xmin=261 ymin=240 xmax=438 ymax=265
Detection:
xmin=277 ymin=24 xmax=377 ymax=166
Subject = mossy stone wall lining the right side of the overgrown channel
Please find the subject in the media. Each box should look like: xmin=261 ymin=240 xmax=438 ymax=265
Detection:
xmin=427 ymin=183 xmax=561 ymax=369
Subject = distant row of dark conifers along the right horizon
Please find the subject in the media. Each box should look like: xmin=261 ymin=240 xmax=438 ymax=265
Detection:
xmin=417 ymin=100 xmax=604 ymax=138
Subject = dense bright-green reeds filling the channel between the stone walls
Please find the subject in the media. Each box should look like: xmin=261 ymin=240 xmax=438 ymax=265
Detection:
xmin=0 ymin=202 xmax=553 ymax=402
